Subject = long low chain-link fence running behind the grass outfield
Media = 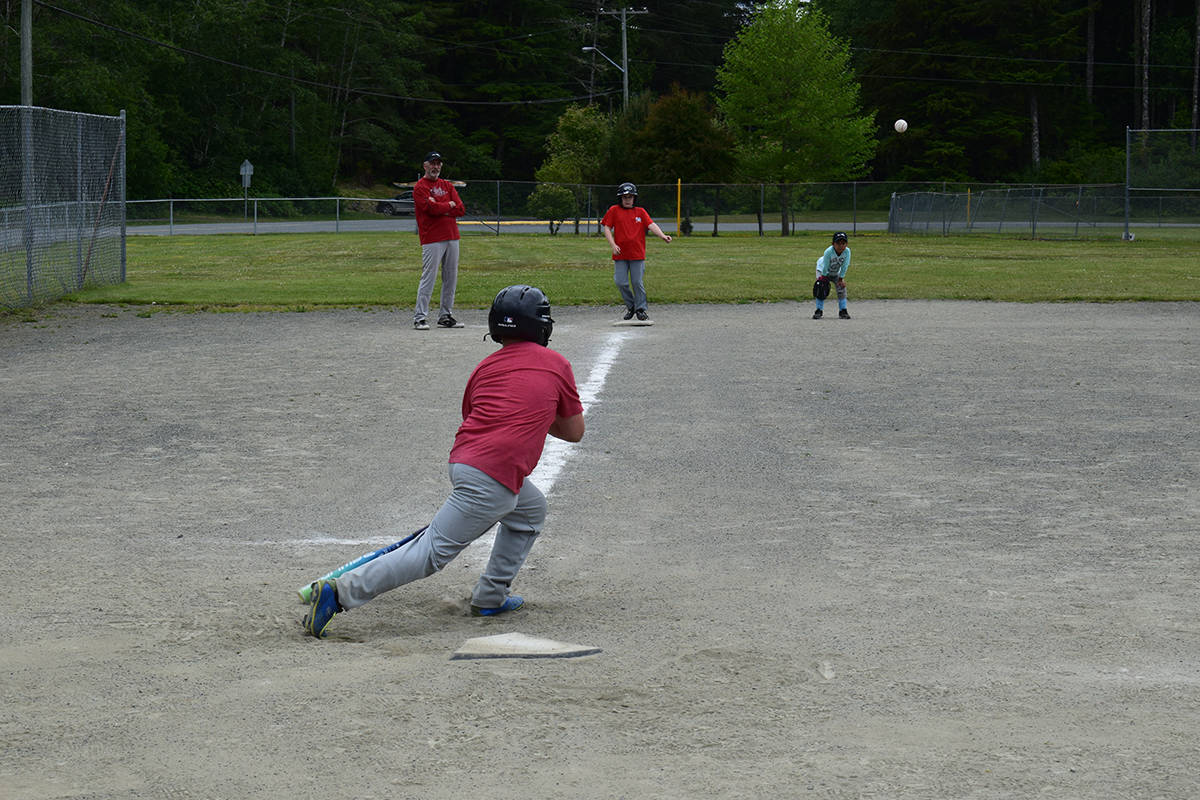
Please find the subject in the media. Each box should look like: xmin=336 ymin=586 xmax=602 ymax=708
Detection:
xmin=128 ymin=180 xmax=1200 ymax=237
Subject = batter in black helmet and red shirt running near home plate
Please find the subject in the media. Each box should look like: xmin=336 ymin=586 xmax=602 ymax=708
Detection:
xmin=304 ymin=285 xmax=583 ymax=638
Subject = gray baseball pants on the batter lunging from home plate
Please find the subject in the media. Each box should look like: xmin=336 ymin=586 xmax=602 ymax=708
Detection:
xmin=337 ymin=464 xmax=546 ymax=608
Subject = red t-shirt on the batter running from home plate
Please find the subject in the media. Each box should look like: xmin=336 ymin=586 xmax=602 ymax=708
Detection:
xmin=450 ymin=342 xmax=583 ymax=494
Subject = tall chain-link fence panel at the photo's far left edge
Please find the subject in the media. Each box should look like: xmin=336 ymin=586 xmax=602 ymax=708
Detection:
xmin=0 ymin=106 xmax=125 ymax=308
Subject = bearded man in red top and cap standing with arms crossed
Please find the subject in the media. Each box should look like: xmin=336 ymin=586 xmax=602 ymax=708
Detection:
xmin=413 ymin=151 xmax=466 ymax=331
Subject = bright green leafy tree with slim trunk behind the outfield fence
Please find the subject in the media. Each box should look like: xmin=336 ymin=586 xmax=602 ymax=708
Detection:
xmin=716 ymin=0 xmax=876 ymax=235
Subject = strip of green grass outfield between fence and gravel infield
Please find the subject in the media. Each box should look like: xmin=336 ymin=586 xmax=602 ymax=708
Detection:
xmin=60 ymin=229 xmax=1200 ymax=311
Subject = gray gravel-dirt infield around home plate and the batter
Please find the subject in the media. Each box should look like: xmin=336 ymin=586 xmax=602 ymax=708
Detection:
xmin=0 ymin=302 xmax=1200 ymax=800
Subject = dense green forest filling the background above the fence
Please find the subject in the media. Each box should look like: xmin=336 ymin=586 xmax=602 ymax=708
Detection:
xmin=0 ymin=0 xmax=1200 ymax=199
